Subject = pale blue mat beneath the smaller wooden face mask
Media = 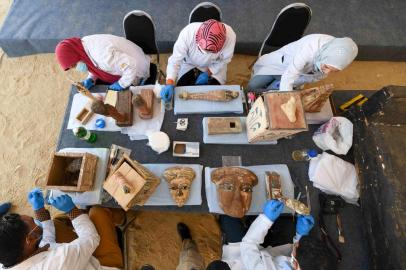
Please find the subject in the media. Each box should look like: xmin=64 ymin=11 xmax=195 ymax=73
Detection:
xmin=143 ymin=164 xmax=203 ymax=205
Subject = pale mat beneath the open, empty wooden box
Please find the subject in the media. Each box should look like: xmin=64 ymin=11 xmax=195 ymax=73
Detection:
xmin=50 ymin=148 xmax=110 ymax=206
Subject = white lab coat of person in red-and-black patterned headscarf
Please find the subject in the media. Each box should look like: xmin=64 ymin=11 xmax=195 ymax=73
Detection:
xmin=166 ymin=22 xmax=236 ymax=84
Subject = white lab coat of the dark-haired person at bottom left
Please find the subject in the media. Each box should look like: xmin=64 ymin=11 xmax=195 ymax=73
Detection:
xmin=2 ymin=214 xmax=119 ymax=270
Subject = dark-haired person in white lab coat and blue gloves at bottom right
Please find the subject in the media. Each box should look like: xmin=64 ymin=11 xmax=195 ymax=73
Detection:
xmin=207 ymin=200 xmax=336 ymax=270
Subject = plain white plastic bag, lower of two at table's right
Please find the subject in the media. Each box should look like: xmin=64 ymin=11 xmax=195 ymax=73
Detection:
xmin=309 ymin=152 xmax=359 ymax=204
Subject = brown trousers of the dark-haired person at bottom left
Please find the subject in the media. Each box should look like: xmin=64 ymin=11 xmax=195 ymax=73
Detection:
xmin=54 ymin=206 xmax=124 ymax=268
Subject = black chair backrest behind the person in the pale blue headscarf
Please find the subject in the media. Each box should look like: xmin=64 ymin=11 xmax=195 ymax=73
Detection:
xmin=258 ymin=3 xmax=312 ymax=57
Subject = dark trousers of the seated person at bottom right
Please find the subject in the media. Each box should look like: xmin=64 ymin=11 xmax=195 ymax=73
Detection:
xmin=219 ymin=215 xmax=296 ymax=247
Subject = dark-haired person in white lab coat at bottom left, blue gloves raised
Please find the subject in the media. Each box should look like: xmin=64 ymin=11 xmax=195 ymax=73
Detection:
xmin=0 ymin=189 xmax=123 ymax=270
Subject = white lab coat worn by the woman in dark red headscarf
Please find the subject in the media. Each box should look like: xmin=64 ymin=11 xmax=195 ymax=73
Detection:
xmin=82 ymin=34 xmax=150 ymax=88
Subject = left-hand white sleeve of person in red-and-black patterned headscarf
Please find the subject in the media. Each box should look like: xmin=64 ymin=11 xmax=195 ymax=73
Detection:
xmin=166 ymin=26 xmax=191 ymax=81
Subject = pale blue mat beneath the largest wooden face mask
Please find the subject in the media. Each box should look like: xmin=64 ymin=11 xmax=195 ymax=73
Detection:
xmin=204 ymin=164 xmax=295 ymax=215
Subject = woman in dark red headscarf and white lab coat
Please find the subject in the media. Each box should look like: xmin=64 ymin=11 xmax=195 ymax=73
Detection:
xmin=55 ymin=34 xmax=150 ymax=91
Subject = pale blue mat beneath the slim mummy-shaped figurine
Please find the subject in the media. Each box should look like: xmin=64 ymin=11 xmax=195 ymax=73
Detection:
xmin=174 ymin=85 xmax=244 ymax=114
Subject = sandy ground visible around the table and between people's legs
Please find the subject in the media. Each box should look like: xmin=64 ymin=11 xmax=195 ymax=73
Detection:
xmin=0 ymin=0 xmax=406 ymax=269
